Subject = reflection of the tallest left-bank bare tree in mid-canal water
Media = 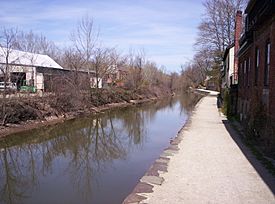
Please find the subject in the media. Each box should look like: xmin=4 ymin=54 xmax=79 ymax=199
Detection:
xmin=64 ymin=115 xmax=126 ymax=202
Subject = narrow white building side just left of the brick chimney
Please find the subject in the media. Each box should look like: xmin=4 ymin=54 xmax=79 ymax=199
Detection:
xmin=222 ymin=44 xmax=235 ymax=89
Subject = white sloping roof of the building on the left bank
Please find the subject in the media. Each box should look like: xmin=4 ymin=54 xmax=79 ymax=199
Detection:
xmin=0 ymin=47 xmax=63 ymax=69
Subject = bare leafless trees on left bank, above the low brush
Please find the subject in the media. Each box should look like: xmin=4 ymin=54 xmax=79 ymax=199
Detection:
xmin=0 ymin=15 xmax=183 ymax=96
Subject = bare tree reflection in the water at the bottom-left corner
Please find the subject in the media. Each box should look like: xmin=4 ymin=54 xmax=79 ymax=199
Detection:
xmin=0 ymin=145 xmax=38 ymax=203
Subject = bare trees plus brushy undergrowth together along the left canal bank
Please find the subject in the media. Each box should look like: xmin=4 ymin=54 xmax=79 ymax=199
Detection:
xmin=0 ymin=15 xmax=188 ymax=125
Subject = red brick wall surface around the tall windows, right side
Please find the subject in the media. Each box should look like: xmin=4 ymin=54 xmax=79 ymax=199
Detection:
xmin=238 ymin=17 xmax=275 ymax=117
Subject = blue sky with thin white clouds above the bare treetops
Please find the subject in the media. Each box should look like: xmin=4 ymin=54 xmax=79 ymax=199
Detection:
xmin=0 ymin=0 xmax=203 ymax=71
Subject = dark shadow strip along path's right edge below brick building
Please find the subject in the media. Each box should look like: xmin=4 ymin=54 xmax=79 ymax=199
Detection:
xmin=222 ymin=120 xmax=275 ymax=194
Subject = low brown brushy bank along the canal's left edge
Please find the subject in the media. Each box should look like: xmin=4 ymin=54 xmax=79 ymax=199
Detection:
xmin=0 ymin=87 xmax=187 ymax=138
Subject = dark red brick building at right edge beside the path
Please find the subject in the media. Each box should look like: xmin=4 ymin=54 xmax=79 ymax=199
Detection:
xmin=238 ymin=0 xmax=275 ymax=150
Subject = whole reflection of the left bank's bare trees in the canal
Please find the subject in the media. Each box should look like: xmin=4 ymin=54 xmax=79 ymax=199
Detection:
xmin=0 ymin=95 xmax=202 ymax=203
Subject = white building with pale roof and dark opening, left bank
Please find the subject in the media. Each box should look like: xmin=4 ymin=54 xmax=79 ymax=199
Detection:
xmin=0 ymin=47 xmax=63 ymax=91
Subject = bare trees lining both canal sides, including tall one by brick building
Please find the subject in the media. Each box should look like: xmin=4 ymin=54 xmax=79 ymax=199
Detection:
xmin=0 ymin=0 xmax=250 ymax=94
